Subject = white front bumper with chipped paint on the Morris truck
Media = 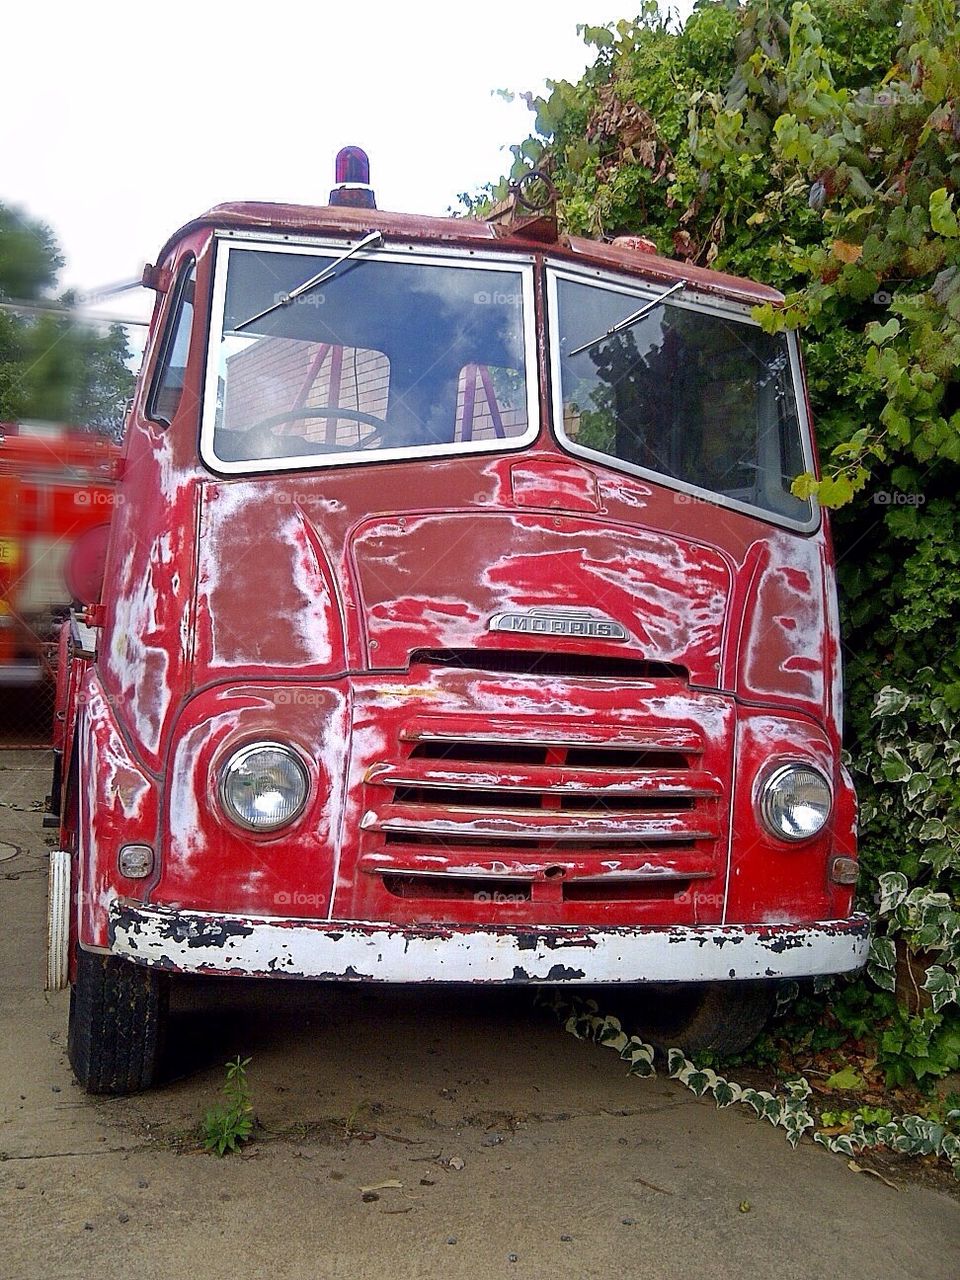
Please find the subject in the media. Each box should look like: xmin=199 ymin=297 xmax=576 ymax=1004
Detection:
xmin=110 ymin=899 xmax=869 ymax=984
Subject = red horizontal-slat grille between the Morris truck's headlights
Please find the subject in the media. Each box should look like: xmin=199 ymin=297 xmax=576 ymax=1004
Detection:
xmin=362 ymin=723 xmax=723 ymax=849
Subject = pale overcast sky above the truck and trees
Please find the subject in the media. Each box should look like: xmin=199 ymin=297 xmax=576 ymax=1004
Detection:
xmin=0 ymin=0 xmax=692 ymax=325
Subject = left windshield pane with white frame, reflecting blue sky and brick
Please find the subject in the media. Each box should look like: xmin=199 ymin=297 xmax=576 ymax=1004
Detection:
xmin=202 ymin=244 xmax=536 ymax=471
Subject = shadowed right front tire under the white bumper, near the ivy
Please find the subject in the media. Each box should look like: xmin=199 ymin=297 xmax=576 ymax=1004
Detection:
xmin=619 ymin=982 xmax=776 ymax=1055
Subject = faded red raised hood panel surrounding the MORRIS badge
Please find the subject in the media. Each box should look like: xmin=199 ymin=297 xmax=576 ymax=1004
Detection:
xmin=352 ymin=512 xmax=731 ymax=687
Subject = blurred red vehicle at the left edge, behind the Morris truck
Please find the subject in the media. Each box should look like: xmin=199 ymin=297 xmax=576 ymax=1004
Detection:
xmin=0 ymin=422 xmax=118 ymax=687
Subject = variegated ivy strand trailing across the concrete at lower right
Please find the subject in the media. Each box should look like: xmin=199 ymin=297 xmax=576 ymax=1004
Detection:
xmin=549 ymin=996 xmax=960 ymax=1179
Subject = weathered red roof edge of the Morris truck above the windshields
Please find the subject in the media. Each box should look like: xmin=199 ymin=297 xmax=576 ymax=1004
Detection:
xmin=157 ymin=202 xmax=783 ymax=306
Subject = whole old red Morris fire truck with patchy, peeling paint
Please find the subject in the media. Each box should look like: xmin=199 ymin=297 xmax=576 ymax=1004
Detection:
xmin=50 ymin=148 xmax=868 ymax=1092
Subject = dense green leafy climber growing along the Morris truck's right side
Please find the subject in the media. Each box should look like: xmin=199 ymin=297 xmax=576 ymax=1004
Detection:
xmin=488 ymin=0 xmax=960 ymax=1074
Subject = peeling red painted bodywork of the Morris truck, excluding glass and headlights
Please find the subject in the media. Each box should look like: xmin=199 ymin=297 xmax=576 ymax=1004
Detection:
xmin=50 ymin=192 xmax=863 ymax=982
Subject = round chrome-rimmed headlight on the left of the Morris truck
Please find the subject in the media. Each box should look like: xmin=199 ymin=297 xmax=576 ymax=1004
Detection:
xmin=220 ymin=742 xmax=310 ymax=831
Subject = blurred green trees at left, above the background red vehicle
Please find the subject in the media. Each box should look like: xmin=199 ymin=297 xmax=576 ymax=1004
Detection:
xmin=0 ymin=205 xmax=133 ymax=434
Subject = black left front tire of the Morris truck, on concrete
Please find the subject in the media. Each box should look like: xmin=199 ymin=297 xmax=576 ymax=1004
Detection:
xmin=67 ymin=951 xmax=169 ymax=1093
